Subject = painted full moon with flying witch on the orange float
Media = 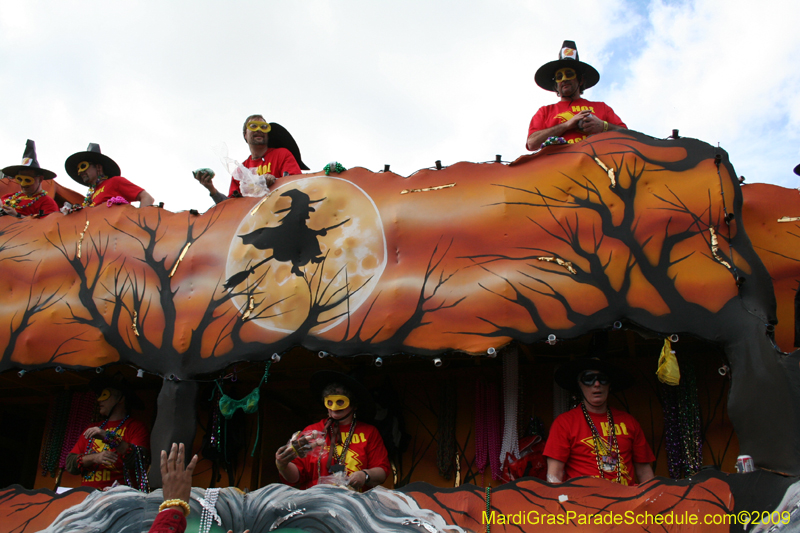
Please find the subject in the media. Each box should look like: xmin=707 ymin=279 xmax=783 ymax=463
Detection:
xmin=226 ymin=176 xmax=386 ymax=333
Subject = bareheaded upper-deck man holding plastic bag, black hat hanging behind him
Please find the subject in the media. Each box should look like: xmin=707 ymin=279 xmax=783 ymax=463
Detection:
xmin=194 ymin=115 xmax=308 ymax=203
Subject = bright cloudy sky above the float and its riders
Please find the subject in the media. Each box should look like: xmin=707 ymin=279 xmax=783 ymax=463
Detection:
xmin=0 ymin=0 xmax=800 ymax=211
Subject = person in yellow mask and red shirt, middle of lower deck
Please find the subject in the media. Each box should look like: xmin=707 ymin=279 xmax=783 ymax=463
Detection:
xmin=275 ymin=371 xmax=391 ymax=490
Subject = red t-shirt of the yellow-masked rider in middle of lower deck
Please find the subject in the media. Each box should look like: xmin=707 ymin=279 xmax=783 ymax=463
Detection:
xmin=283 ymin=420 xmax=391 ymax=489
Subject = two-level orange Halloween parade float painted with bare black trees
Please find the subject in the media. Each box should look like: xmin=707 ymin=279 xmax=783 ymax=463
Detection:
xmin=0 ymin=131 xmax=800 ymax=533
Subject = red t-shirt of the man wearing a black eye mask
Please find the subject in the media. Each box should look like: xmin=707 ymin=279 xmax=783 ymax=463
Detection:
xmin=544 ymin=406 xmax=656 ymax=485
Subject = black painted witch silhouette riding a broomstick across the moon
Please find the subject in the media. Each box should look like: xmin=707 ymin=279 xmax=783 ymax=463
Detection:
xmin=224 ymin=189 xmax=350 ymax=290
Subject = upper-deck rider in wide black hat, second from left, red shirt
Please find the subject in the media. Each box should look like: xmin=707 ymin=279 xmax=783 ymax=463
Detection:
xmin=64 ymin=143 xmax=155 ymax=207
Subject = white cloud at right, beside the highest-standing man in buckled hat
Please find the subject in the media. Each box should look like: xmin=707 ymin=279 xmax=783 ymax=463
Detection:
xmin=608 ymin=0 xmax=800 ymax=186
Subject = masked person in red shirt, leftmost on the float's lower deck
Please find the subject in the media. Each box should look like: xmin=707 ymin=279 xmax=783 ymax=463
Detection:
xmin=66 ymin=375 xmax=150 ymax=490
